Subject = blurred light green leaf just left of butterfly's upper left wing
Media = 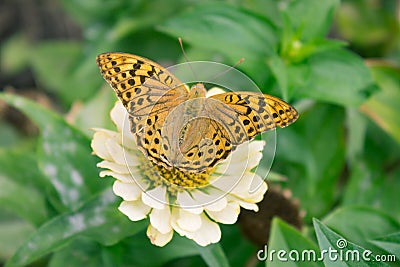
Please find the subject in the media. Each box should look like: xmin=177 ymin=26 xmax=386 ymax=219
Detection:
xmin=30 ymin=40 xmax=102 ymax=107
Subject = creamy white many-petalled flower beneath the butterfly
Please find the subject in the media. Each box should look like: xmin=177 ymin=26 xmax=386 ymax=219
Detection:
xmin=92 ymin=90 xmax=267 ymax=246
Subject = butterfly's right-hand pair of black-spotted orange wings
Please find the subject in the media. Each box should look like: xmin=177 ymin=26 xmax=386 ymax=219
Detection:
xmin=164 ymin=92 xmax=298 ymax=172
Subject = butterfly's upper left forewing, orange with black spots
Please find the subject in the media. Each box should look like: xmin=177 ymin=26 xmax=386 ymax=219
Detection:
xmin=97 ymin=53 xmax=188 ymax=110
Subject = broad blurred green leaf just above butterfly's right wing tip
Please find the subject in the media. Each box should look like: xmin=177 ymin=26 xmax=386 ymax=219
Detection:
xmin=289 ymin=49 xmax=377 ymax=107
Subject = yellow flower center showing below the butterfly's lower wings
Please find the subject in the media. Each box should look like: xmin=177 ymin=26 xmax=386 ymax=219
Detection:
xmin=140 ymin=156 xmax=214 ymax=191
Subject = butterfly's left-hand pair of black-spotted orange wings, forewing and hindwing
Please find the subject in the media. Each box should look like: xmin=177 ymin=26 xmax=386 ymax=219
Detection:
xmin=97 ymin=53 xmax=189 ymax=168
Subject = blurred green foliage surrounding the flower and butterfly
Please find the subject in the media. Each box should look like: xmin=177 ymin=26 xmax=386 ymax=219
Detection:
xmin=0 ymin=0 xmax=400 ymax=267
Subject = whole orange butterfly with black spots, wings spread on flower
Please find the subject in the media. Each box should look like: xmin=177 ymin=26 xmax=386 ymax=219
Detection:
xmin=96 ymin=53 xmax=298 ymax=173
